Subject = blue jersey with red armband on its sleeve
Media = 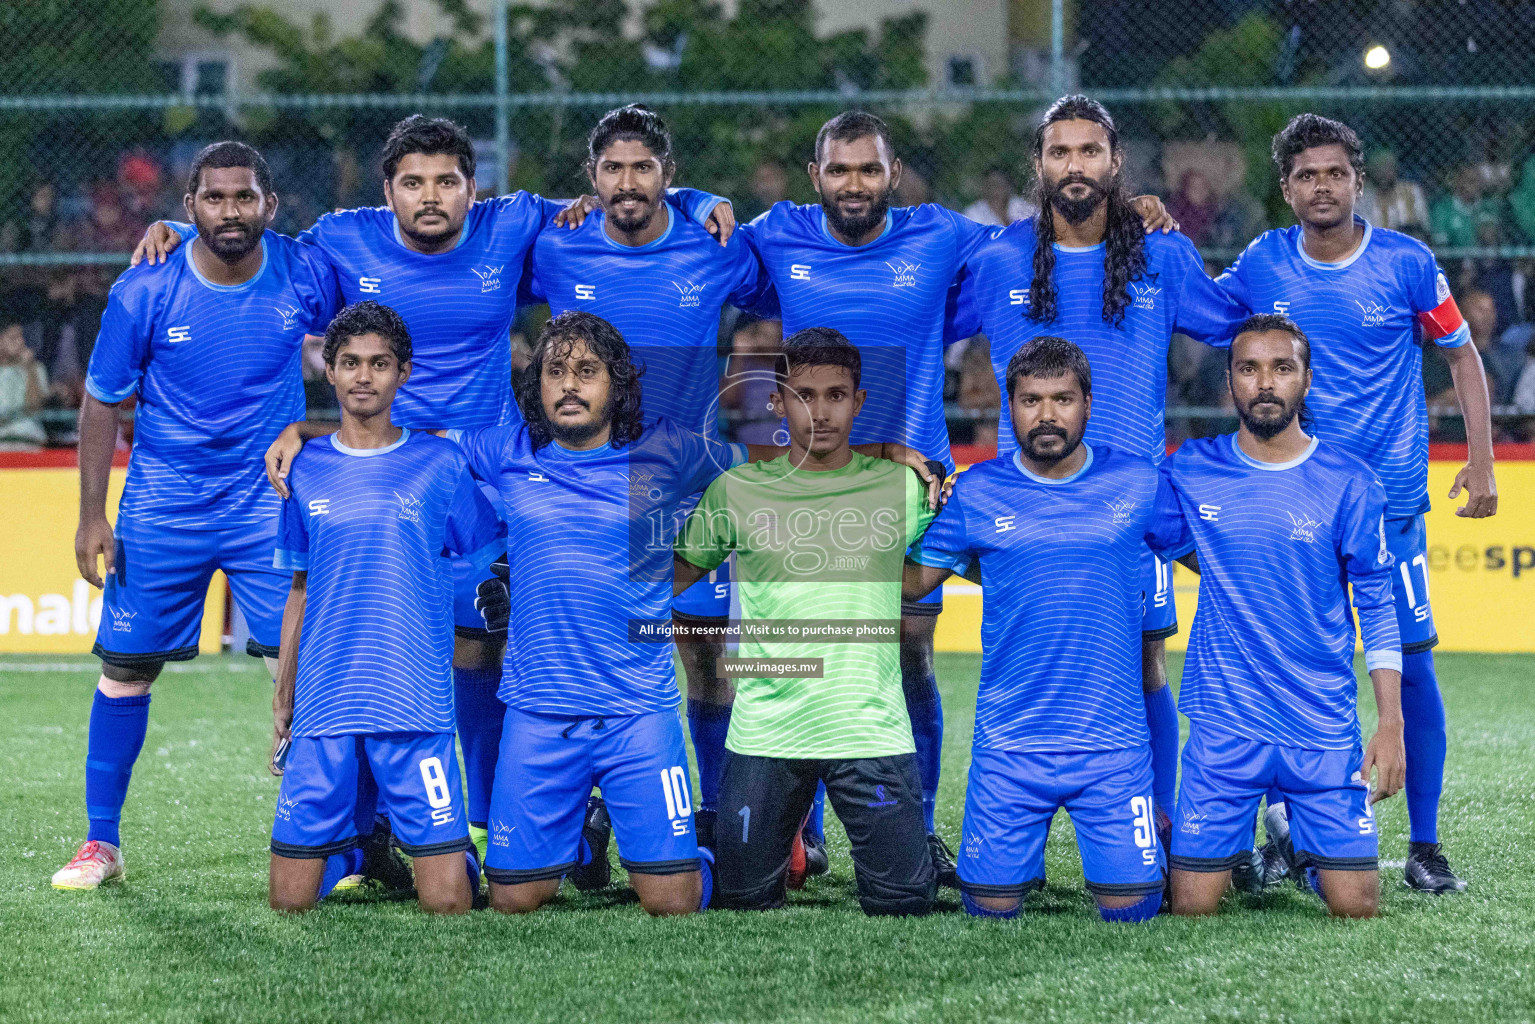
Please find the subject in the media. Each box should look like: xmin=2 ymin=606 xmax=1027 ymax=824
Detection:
xmin=1220 ymin=218 xmax=1471 ymax=517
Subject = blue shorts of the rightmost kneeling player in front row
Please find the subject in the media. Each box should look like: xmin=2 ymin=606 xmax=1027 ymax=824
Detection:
xmin=1168 ymin=722 xmax=1380 ymax=872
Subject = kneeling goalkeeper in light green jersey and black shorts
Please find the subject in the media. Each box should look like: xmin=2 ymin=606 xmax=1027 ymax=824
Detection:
xmin=675 ymin=327 xmax=936 ymax=915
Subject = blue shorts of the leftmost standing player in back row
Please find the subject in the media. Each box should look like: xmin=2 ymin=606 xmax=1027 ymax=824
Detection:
xmin=92 ymin=516 xmax=293 ymax=668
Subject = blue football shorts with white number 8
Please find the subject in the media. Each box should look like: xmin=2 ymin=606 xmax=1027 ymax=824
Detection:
xmin=272 ymin=732 xmax=473 ymax=858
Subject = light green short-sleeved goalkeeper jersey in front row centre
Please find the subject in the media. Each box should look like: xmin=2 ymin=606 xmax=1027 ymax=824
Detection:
xmin=677 ymin=451 xmax=933 ymax=758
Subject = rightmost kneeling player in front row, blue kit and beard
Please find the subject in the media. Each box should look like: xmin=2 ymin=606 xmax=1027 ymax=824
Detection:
xmin=1167 ymin=313 xmax=1406 ymax=917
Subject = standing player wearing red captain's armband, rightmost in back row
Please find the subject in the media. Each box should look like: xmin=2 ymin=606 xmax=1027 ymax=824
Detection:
xmin=1220 ymin=114 xmax=1498 ymax=892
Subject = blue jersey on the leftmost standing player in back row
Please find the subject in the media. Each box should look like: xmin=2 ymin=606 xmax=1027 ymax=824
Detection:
xmin=86 ymin=232 xmax=336 ymax=530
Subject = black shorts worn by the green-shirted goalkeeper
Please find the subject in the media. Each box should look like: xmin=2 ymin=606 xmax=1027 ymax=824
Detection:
xmin=714 ymin=751 xmax=938 ymax=915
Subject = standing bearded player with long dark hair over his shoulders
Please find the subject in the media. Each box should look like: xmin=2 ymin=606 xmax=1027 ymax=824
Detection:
xmin=949 ymin=95 xmax=1243 ymax=829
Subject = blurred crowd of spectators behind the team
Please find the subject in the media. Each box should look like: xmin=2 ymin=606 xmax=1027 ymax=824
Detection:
xmin=0 ymin=143 xmax=1535 ymax=450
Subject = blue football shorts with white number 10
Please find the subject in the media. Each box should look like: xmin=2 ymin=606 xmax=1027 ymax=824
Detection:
xmin=485 ymin=708 xmax=700 ymax=886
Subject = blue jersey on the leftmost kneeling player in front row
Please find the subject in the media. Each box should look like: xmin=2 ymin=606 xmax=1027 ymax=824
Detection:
xmin=273 ymin=430 xmax=507 ymax=735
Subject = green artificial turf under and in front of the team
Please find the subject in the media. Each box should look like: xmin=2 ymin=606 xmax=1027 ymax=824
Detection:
xmin=0 ymin=654 xmax=1535 ymax=1024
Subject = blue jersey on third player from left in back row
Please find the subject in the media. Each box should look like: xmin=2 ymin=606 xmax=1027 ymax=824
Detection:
xmin=527 ymin=207 xmax=761 ymax=436
